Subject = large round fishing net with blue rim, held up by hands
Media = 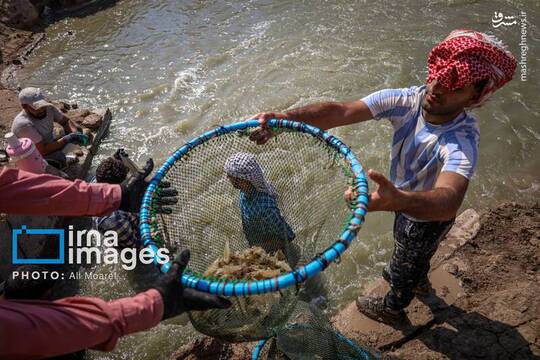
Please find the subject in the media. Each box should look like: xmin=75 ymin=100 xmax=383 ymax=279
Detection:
xmin=140 ymin=120 xmax=367 ymax=341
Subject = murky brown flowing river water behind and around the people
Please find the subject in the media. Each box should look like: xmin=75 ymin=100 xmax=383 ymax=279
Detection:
xmin=17 ymin=0 xmax=540 ymax=359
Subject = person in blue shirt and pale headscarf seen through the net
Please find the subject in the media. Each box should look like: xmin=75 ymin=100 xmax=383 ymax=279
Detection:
xmin=224 ymin=152 xmax=295 ymax=253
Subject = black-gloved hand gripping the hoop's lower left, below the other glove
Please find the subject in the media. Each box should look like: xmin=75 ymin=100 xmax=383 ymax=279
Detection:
xmin=153 ymin=250 xmax=231 ymax=320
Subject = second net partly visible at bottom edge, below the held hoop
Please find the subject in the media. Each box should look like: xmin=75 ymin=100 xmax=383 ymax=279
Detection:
xmin=252 ymin=301 xmax=379 ymax=360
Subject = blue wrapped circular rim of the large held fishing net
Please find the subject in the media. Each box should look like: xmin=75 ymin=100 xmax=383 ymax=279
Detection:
xmin=139 ymin=119 xmax=368 ymax=296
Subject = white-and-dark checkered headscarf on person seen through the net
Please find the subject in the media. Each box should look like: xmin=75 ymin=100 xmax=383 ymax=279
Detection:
xmin=224 ymin=152 xmax=277 ymax=197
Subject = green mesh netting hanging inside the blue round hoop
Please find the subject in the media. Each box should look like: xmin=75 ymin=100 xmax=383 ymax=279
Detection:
xmin=150 ymin=131 xmax=358 ymax=341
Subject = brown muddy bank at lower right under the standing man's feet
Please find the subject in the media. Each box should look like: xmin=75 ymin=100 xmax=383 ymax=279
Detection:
xmin=334 ymin=203 xmax=540 ymax=359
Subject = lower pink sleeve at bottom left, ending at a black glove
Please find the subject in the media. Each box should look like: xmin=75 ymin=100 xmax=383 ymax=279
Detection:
xmin=0 ymin=289 xmax=163 ymax=359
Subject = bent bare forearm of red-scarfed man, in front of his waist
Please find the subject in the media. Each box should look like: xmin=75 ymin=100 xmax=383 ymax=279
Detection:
xmin=393 ymin=188 xmax=463 ymax=221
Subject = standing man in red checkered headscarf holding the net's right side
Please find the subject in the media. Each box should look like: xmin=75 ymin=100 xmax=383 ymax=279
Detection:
xmin=251 ymin=30 xmax=517 ymax=323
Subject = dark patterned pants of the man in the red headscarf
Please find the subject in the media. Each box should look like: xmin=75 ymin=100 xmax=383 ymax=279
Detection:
xmin=384 ymin=213 xmax=454 ymax=310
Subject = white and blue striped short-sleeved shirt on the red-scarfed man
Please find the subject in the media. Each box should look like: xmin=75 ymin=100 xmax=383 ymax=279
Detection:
xmin=362 ymin=86 xmax=480 ymax=191
